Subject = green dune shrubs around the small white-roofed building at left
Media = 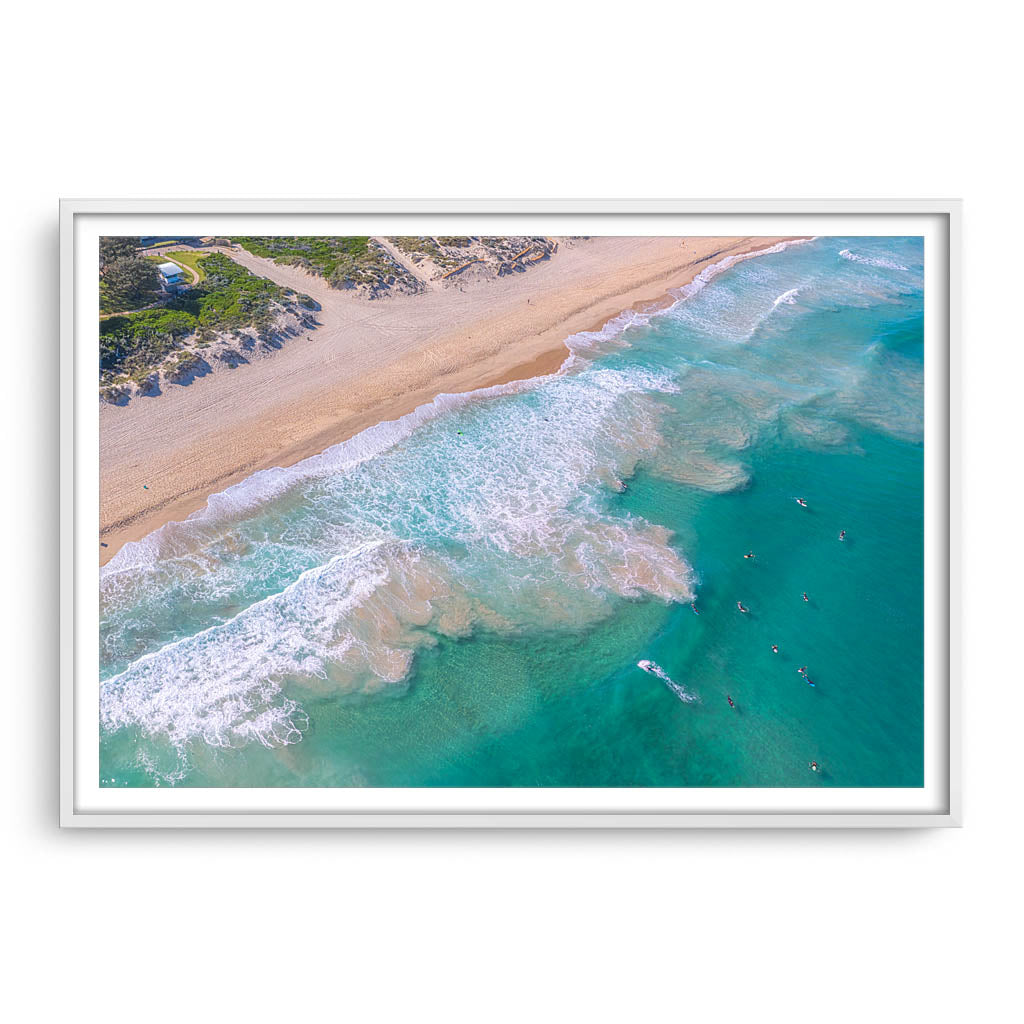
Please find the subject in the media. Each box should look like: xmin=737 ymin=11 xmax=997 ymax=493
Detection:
xmin=99 ymin=253 xmax=285 ymax=385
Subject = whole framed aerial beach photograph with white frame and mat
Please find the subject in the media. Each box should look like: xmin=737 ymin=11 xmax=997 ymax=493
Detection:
xmin=60 ymin=200 xmax=961 ymax=827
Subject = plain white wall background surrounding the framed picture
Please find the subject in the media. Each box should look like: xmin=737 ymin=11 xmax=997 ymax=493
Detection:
xmin=0 ymin=0 xmax=1024 ymax=1022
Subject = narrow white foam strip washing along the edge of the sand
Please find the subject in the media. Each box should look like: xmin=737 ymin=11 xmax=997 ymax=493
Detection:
xmin=99 ymin=238 xmax=815 ymax=586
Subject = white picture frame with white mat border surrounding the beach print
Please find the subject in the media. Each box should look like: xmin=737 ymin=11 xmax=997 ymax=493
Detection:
xmin=59 ymin=199 xmax=962 ymax=828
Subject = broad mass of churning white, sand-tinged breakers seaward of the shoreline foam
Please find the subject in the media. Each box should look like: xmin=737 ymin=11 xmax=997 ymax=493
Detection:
xmin=101 ymin=366 xmax=692 ymax=750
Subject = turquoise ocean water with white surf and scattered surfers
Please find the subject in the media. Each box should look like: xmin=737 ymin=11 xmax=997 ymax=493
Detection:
xmin=99 ymin=238 xmax=924 ymax=786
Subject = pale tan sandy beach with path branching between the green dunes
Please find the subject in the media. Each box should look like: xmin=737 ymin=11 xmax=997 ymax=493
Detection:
xmin=99 ymin=237 xmax=806 ymax=564
